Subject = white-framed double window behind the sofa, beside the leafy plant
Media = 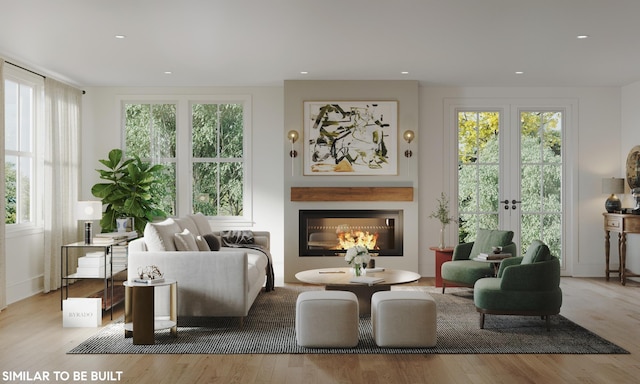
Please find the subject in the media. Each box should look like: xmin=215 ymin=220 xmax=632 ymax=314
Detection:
xmin=122 ymin=96 xmax=251 ymax=225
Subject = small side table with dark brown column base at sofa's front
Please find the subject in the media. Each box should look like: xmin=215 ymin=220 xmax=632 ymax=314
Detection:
xmin=124 ymin=279 xmax=178 ymax=345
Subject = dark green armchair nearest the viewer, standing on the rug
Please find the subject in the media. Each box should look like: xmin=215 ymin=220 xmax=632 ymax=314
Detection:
xmin=473 ymin=240 xmax=562 ymax=331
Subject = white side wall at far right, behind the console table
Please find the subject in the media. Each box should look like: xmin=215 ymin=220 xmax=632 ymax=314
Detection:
xmin=613 ymin=81 xmax=640 ymax=273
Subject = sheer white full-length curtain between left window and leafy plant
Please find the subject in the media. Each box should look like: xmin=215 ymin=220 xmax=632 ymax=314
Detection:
xmin=44 ymin=78 xmax=82 ymax=292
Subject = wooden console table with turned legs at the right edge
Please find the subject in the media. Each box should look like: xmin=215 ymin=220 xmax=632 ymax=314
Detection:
xmin=602 ymin=213 xmax=640 ymax=285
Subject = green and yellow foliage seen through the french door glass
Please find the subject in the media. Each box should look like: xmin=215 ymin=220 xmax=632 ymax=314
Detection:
xmin=458 ymin=112 xmax=562 ymax=257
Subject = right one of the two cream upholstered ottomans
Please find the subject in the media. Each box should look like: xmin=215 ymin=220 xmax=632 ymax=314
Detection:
xmin=371 ymin=291 xmax=437 ymax=347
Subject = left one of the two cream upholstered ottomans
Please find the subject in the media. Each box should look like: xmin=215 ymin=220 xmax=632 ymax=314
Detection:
xmin=296 ymin=291 xmax=359 ymax=348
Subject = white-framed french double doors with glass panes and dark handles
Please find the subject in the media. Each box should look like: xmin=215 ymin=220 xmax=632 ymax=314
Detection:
xmin=452 ymin=104 xmax=568 ymax=258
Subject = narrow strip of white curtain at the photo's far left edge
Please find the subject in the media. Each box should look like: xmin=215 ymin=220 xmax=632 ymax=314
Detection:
xmin=0 ymin=57 xmax=7 ymax=310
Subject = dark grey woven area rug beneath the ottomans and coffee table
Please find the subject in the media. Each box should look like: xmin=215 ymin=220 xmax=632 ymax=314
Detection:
xmin=68 ymin=286 xmax=628 ymax=354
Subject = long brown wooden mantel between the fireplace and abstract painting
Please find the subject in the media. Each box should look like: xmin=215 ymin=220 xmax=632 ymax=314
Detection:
xmin=291 ymin=187 xmax=413 ymax=201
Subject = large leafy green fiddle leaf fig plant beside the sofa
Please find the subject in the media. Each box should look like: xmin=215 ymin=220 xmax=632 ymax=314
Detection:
xmin=91 ymin=148 xmax=167 ymax=234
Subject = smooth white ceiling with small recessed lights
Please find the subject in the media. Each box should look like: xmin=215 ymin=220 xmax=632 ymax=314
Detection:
xmin=0 ymin=0 xmax=640 ymax=86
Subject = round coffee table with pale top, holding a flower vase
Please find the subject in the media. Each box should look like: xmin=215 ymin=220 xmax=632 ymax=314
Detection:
xmin=296 ymin=268 xmax=420 ymax=315
